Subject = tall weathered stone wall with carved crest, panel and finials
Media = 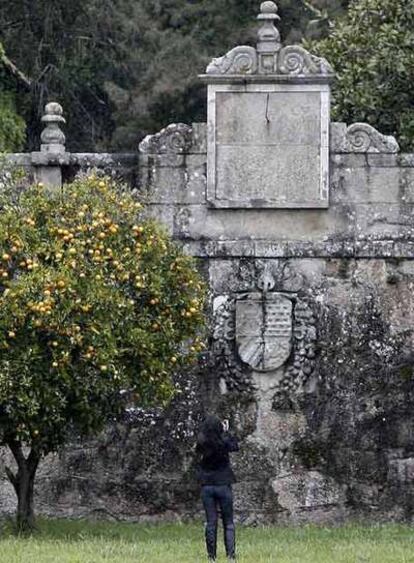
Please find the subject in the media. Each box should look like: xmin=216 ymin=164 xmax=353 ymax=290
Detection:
xmin=0 ymin=2 xmax=414 ymax=523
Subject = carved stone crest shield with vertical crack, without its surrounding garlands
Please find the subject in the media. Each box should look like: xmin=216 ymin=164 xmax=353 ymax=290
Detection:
xmin=236 ymin=293 xmax=293 ymax=372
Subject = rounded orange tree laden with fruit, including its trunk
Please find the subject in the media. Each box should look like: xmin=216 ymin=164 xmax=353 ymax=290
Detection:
xmin=0 ymin=175 xmax=205 ymax=529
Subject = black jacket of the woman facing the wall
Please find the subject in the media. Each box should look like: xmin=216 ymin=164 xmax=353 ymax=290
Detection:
xmin=196 ymin=434 xmax=239 ymax=485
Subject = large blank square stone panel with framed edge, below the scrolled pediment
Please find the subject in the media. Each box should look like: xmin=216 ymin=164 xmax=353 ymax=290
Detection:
xmin=207 ymin=84 xmax=329 ymax=209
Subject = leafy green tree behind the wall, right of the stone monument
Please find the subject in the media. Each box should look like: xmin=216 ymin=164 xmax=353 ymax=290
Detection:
xmin=308 ymin=0 xmax=414 ymax=150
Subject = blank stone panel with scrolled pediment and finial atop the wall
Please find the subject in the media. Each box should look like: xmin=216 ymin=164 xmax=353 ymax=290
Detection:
xmin=202 ymin=2 xmax=333 ymax=209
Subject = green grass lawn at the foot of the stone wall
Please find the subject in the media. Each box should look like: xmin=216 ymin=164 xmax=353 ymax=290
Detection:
xmin=0 ymin=521 xmax=414 ymax=563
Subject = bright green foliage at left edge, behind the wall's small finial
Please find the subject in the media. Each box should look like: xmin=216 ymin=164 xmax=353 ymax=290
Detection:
xmin=0 ymin=43 xmax=26 ymax=152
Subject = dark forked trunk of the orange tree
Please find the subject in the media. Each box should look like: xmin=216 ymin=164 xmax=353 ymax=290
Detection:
xmin=6 ymin=442 xmax=40 ymax=532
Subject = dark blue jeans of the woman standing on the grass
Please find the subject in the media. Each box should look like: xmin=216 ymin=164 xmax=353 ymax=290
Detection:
xmin=201 ymin=485 xmax=236 ymax=559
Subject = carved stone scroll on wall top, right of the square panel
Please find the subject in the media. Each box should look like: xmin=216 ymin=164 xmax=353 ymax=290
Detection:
xmin=331 ymin=123 xmax=400 ymax=154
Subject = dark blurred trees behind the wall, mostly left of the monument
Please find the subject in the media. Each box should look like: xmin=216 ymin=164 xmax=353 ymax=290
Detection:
xmin=0 ymin=0 xmax=334 ymax=151
